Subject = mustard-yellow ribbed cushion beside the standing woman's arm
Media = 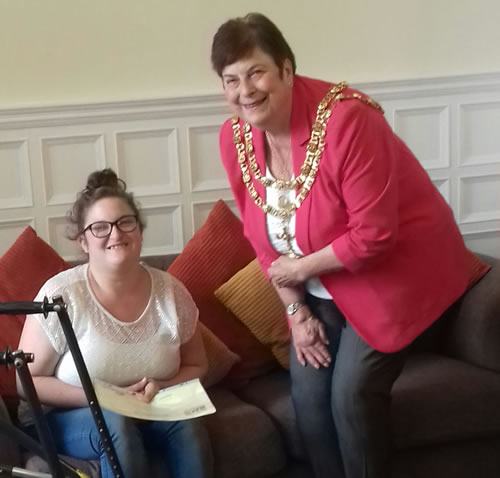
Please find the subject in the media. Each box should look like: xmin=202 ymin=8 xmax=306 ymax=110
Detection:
xmin=215 ymin=259 xmax=290 ymax=368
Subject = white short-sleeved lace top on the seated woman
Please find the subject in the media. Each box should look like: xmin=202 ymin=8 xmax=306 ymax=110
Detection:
xmin=31 ymin=264 xmax=198 ymax=386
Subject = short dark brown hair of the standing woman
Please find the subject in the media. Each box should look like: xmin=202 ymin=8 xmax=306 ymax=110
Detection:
xmin=211 ymin=13 xmax=296 ymax=77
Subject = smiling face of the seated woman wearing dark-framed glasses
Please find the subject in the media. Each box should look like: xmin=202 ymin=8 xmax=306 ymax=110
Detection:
xmin=78 ymin=197 xmax=142 ymax=268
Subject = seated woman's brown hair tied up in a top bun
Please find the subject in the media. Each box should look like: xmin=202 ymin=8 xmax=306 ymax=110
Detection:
xmin=66 ymin=168 xmax=145 ymax=240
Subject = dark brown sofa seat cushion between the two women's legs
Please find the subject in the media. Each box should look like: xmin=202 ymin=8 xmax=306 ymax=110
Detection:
xmin=204 ymin=387 xmax=287 ymax=478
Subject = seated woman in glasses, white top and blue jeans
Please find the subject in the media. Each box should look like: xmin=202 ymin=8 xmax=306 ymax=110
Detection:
xmin=18 ymin=169 xmax=212 ymax=478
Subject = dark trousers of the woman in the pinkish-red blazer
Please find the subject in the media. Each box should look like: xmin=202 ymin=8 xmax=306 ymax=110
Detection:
xmin=290 ymin=295 xmax=409 ymax=478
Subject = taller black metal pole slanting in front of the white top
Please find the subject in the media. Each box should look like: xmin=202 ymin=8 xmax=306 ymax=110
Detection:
xmin=52 ymin=295 xmax=123 ymax=478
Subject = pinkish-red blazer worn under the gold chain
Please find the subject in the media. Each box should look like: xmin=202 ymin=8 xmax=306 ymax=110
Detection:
xmin=220 ymin=76 xmax=488 ymax=353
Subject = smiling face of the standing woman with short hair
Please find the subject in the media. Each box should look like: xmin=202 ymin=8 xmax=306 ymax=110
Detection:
xmin=222 ymin=48 xmax=293 ymax=132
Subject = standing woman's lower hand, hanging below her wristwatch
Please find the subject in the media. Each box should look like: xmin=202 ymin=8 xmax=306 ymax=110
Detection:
xmin=291 ymin=315 xmax=332 ymax=369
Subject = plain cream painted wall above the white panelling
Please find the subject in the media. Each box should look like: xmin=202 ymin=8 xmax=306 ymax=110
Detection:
xmin=0 ymin=0 xmax=500 ymax=109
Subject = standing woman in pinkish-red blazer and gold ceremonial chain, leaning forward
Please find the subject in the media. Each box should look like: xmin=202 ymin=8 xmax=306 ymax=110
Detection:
xmin=212 ymin=13 xmax=487 ymax=478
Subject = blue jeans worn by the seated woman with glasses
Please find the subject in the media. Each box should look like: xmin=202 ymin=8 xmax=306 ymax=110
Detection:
xmin=40 ymin=408 xmax=213 ymax=478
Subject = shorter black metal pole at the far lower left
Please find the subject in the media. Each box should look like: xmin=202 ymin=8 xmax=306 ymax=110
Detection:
xmin=11 ymin=350 xmax=64 ymax=478
